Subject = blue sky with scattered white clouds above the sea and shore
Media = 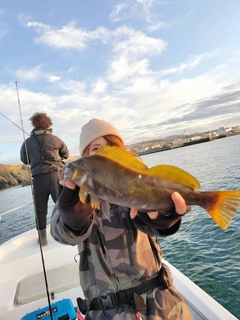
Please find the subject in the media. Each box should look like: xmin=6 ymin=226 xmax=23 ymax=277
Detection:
xmin=0 ymin=0 xmax=240 ymax=164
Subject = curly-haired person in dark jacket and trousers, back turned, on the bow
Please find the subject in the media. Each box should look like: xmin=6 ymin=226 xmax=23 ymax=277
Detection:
xmin=20 ymin=112 xmax=69 ymax=246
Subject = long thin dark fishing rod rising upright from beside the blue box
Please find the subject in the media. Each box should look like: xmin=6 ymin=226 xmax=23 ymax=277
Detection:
xmin=15 ymin=81 xmax=53 ymax=320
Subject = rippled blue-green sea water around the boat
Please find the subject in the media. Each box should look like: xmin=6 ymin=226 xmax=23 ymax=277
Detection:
xmin=0 ymin=135 xmax=240 ymax=319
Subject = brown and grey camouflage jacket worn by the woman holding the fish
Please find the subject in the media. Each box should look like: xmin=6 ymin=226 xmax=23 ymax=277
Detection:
xmin=51 ymin=202 xmax=193 ymax=320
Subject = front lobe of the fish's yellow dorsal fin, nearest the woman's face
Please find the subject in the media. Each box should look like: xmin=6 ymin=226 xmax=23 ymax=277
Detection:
xmin=96 ymin=146 xmax=148 ymax=173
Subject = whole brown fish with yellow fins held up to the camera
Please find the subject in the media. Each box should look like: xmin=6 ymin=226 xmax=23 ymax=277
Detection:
xmin=59 ymin=146 xmax=240 ymax=230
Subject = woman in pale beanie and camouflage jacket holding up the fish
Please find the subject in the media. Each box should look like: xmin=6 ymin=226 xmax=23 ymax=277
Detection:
xmin=51 ymin=119 xmax=193 ymax=320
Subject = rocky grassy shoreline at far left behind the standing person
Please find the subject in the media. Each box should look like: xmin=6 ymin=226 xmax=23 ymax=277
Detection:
xmin=0 ymin=164 xmax=31 ymax=190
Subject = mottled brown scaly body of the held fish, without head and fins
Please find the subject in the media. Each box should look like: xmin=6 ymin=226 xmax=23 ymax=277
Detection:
xmin=82 ymin=155 xmax=211 ymax=212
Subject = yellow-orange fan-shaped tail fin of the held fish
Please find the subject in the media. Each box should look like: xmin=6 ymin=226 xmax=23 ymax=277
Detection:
xmin=203 ymin=190 xmax=240 ymax=230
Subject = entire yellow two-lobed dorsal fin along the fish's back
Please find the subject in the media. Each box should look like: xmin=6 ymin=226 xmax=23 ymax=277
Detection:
xmin=95 ymin=146 xmax=200 ymax=190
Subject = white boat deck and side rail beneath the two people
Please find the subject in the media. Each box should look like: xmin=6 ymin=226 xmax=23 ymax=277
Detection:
xmin=0 ymin=229 xmax=237 ymax=320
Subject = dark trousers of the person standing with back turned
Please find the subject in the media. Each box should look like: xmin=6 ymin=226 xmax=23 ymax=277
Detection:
xmin=33 ymin=171 xmax=59 ymax=230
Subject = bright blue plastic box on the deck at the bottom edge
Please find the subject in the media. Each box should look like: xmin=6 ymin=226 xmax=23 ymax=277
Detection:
xmin=21 ymin=299 xmax=77 ymax=320
